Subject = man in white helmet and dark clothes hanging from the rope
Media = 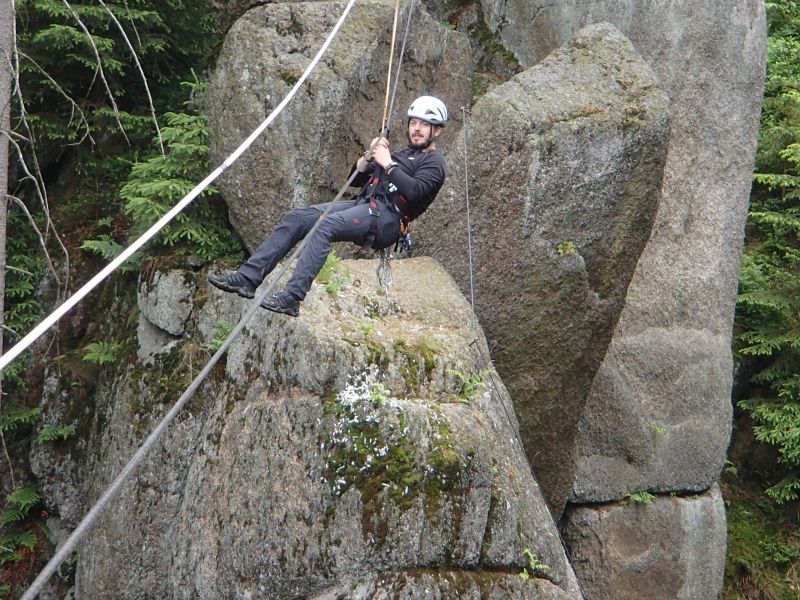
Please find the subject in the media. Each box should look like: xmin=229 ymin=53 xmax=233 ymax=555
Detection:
xmin=208 ymin=96 xmax=447 ymax=317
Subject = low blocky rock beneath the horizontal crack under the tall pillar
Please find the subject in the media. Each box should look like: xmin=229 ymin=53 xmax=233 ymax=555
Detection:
xmin=563 ymin=485 xmax=727 ymax=600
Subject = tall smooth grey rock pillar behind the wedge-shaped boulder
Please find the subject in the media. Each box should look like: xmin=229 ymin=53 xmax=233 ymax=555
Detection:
xmin=481 ymin=0 xmax=766 ymax=502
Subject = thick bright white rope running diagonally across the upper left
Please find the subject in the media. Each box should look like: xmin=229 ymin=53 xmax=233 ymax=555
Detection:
xmin=0 ymin=0 xmax=356 ymax=371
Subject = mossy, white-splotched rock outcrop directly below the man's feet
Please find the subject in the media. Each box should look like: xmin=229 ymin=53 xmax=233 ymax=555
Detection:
xmin=70 ymin=259 xmax=582 ymax=600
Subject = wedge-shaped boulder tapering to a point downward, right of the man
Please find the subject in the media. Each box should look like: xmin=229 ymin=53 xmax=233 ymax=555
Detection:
xmin=417 ymin=24 xmax=669 ymax=514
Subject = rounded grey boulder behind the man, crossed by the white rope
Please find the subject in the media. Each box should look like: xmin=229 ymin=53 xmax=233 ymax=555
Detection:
xmin=208 ymin=0 xmax=472 ymax=250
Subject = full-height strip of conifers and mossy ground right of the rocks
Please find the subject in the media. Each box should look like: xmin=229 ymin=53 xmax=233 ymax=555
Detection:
xmin=723 ymin=0 xmax=800 ymax=600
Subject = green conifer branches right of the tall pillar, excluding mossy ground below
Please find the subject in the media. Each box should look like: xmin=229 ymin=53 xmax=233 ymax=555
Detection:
xmin=735 ymin=0 xmax=800 ymax=502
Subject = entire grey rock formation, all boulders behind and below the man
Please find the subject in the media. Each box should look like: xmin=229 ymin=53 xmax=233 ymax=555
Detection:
xmin=25 ymin=0 xmax=764 ymax=600
